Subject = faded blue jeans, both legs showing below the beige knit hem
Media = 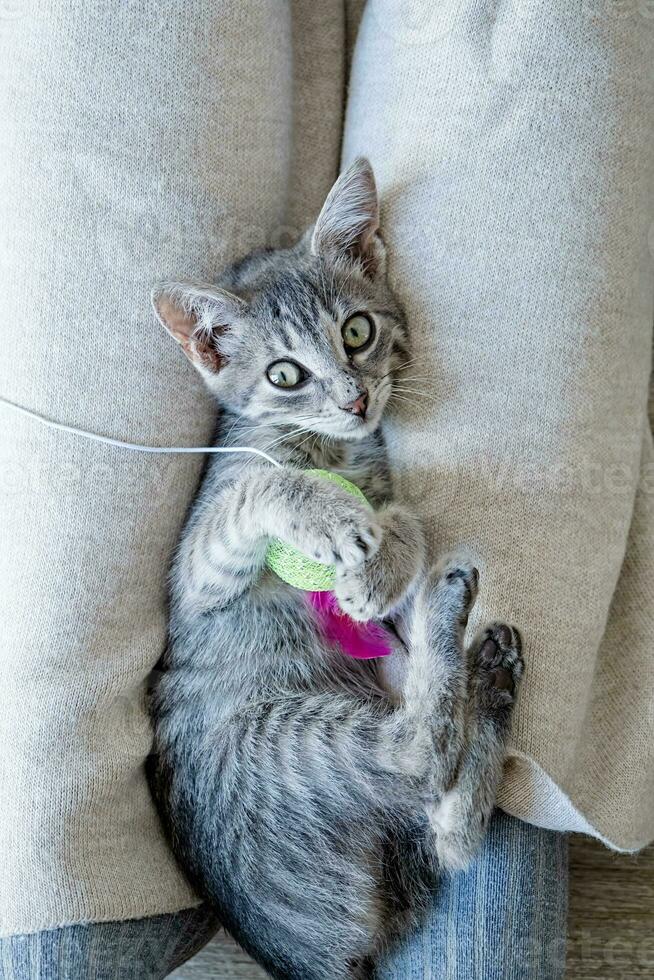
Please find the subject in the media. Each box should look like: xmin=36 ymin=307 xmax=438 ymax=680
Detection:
xmin=0 ymin=812 xmax=568 ymax=980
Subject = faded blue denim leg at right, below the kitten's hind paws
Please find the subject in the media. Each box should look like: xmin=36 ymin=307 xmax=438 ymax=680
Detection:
xmin=377 ymin=811 xmax=568 ymax=980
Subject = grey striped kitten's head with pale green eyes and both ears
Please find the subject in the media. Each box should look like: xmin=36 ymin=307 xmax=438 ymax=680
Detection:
xmin=153 ymin=159 xmax=406 ymax=439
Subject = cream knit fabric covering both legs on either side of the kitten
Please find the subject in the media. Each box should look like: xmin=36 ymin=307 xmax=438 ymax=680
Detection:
xmin=0 ymin=0 xmax=654 ymax=934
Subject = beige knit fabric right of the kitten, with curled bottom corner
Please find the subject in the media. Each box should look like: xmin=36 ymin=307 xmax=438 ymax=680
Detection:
xmin=344 ymin=0 xmax=654 ymax=849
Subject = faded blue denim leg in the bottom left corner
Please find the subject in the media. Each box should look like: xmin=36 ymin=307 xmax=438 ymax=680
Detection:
xmin=0 ymin=906 xmax=218 ymax=980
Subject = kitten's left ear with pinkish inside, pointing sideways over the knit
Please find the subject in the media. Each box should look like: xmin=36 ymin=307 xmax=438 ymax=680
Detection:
xmin=152 ymin=282 xmax=247 ymax=374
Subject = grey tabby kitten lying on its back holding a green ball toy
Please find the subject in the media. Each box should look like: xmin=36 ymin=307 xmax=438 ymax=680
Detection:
xmin=149 ymin=159 xmax=522 ymax=980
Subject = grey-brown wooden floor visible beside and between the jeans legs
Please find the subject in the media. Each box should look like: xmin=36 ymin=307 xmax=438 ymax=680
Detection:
xmin=173 ymin=838 xmax=654 ymax=980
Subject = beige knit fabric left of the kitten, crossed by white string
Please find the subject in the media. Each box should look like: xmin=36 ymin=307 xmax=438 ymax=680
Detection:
xmin=0 ymin=0 xmax=344 ymax=934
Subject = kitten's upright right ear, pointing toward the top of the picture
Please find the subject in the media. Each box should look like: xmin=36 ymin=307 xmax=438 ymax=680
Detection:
xmin=311 ymin=157 xmax=384 ymax=276
